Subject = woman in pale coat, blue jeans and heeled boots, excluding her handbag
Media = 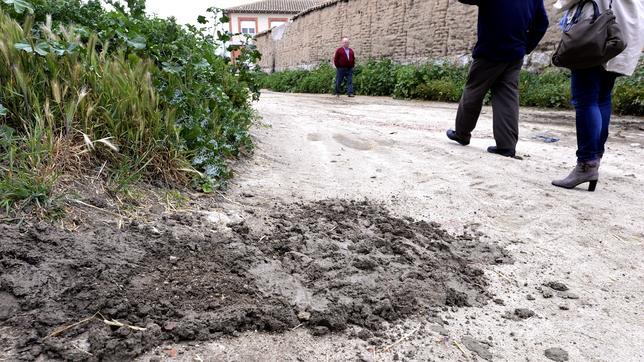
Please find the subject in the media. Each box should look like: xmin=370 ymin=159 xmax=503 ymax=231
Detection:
xmin=552 ymin=0 xmax=644 ymax=191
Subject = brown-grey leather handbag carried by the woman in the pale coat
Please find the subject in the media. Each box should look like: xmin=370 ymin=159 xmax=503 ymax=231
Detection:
xmin=552 ymin=0 xmax=627 ymax=70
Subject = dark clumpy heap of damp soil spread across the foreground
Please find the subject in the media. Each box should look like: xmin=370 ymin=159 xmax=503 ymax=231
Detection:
xmin=0 ymin=200 xmax=509 ymax=360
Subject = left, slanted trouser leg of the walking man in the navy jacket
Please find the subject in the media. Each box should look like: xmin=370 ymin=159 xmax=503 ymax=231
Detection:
xmin=455 ymin=59 xmax=507 ymax=143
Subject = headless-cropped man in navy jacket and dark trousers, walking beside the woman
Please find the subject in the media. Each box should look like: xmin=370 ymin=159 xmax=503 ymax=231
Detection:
xmin=447 ymin=0 xmax=548 ymax=157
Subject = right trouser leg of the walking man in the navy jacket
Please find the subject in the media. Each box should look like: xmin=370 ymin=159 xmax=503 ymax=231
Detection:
xmin=492 ymin=59 xmax=523 ymax=154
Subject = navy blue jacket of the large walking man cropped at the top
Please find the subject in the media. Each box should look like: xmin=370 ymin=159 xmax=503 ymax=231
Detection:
xmin=466 ymin=0 xmax=548 ymax=62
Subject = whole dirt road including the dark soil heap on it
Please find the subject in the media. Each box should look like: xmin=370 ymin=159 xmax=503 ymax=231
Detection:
xmin=0 ymin=92 xmax=644 ymax=362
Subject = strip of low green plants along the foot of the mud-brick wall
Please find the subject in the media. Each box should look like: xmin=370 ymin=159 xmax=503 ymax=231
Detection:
xmin=261 ymin=60 xmax=644 ymax=116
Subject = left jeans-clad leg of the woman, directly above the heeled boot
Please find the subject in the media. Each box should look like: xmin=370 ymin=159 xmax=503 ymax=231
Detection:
xmin=570 ymin=67 xmax=604 ymax=162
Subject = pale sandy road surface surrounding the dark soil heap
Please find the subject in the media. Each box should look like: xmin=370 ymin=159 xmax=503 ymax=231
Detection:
xmin=143 ymin=92 xmax=644 ymax=361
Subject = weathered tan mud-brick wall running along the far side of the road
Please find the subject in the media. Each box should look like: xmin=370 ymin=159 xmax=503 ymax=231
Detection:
xmin=256 ymin=0 xmax=558 ymax=71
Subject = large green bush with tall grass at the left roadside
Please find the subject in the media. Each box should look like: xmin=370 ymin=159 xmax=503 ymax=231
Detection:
xmin=0 ymin=0 xmax=259 ymax=211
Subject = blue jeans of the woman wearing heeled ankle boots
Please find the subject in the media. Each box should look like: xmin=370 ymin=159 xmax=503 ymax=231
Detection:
xmin=571 ymin=67 xmax=617 ymax=162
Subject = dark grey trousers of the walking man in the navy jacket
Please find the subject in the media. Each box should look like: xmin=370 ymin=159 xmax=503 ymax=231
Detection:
xmin=456 ymin=59 xmax=523 ymax=150
